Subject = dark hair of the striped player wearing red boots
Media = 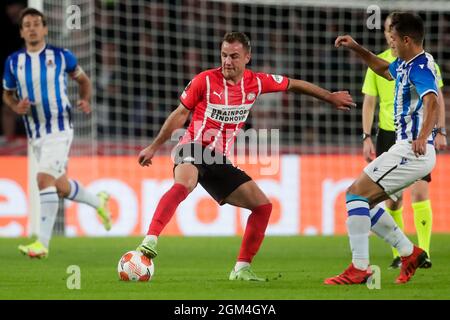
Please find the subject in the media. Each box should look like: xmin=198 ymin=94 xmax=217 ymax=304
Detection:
xmin=389 ymin=12 xmax=424 ymax=45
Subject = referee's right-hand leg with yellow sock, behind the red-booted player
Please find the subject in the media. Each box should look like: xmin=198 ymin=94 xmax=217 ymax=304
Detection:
xmin=411 ymin=180 xmax=433 ymax=268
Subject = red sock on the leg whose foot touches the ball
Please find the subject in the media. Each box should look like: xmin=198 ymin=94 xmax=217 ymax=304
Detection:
xmin=147 ymin=183 xmax=189 ymax=236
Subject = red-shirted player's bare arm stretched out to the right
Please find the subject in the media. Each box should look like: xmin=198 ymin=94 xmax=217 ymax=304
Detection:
xmin=288 ymin=79 xmax=356 ymax=110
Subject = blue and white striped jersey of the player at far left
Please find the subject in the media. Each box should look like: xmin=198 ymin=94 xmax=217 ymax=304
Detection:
xmin=3 ymin=45 xmax=77 ymax=139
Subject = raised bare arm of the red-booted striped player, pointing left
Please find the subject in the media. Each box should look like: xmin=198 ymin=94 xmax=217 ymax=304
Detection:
xmin=334 ymin=35 xmax=393 ymax=80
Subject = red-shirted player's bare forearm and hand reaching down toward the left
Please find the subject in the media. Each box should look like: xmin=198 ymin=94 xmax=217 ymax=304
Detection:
xmin=138 ymin=103 xmax=191 ymax=167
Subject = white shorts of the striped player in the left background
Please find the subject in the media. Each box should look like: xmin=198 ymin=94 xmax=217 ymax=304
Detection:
xmin=31 ymin=131 xmax=73 ymax=179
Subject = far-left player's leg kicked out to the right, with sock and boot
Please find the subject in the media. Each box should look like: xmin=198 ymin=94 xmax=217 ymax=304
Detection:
xmin=56 ymin=174 xmax=111 ymax=230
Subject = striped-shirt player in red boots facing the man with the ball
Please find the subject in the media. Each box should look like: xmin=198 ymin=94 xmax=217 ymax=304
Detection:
xmin=325 ymin=12 xmax=439 ymax=285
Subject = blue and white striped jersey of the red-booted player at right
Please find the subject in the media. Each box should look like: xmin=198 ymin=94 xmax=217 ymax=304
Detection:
xmin=389 ymin=51 xmax=438 ymax=141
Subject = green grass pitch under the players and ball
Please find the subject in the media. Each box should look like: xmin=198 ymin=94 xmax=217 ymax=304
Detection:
xmin=0 ymin=235 xmax=450 ymax=300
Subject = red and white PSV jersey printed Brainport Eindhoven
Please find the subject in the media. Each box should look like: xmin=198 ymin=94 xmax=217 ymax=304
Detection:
xmin=180 ymin=68 xmax=289 ymax=155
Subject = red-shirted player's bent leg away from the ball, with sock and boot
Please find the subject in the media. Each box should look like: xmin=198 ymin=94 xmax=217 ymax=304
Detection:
xmin=223 ymin=180 xmax=272 ymax=281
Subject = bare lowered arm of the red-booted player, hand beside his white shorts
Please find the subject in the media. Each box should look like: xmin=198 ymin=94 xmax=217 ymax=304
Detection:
xmin=412 ymin=92 xmax=439 ymax=156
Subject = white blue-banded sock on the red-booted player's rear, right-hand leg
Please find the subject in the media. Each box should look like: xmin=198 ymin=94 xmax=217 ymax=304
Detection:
xmin=370 ymin=206 xmax=414 ymax=257
